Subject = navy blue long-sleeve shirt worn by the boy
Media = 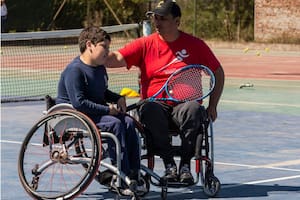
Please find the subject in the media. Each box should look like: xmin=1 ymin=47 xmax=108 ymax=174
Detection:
xmin=56 ymin=56 xmax=121 ymax=121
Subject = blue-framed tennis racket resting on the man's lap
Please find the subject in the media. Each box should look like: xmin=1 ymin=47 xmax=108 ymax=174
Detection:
xmin=127 ymin=65 xmax=215 ymax=110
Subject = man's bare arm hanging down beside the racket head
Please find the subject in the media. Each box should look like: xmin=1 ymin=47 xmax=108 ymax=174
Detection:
xmin=206 ymin=66 xmax=225 ymax=121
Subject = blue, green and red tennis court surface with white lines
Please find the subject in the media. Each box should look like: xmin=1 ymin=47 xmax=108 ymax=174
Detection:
xmin=1 ymin=43 xmax=300 ymax=200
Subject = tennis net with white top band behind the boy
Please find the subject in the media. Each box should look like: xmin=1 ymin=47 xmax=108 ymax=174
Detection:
xmin=1 ymin=24 xmax=140 ymax=103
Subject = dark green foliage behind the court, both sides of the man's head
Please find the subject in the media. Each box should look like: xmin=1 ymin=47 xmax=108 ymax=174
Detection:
xmin=7 ymin=0 xmax=254 ymax=41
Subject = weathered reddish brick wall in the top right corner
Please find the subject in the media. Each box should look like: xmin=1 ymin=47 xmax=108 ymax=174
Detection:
xmin=254 ymin=0 xmax=300 ymax=41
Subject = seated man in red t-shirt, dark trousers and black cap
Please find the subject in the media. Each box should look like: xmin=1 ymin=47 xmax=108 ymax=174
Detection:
xmin=106 ymin=0 xmax=224 ymax=184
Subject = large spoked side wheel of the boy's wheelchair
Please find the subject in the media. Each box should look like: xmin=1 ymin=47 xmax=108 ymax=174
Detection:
xmin=18 ymin=110 xmax=101 ymax=199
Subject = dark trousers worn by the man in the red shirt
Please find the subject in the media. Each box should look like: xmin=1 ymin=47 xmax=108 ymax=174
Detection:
xmin=140 ymin=101 xmax=206 ymax=166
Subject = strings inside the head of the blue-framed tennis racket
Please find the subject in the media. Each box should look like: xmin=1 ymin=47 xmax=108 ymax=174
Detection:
xmin=167 ymin=68 xmax=207 ymax=101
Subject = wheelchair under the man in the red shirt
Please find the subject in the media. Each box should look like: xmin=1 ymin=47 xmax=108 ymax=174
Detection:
xmin=141 ymin=115 xmax=221 ymax=199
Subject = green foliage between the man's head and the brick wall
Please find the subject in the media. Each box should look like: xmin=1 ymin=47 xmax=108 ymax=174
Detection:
xmin=178 ymin=0 xmax=254 ymax=41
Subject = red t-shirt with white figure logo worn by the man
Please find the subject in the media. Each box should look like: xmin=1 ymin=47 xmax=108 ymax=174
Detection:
xmin=119 ymin=32 xmax=220 ymax=98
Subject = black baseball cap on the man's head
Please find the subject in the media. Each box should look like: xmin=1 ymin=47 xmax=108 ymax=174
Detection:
xmin=146 ymin=0 xmax=181 ymax=17
